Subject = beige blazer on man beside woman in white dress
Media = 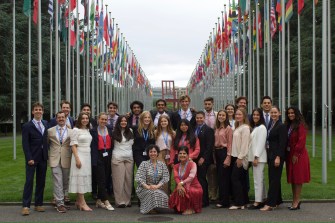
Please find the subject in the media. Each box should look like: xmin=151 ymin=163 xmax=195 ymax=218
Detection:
xmin=48 ymin=125 xmax=73 ymax=168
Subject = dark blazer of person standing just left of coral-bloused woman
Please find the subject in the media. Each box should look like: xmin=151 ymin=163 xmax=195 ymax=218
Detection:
xmin=195 ymin=124 xmax=215 ymax=165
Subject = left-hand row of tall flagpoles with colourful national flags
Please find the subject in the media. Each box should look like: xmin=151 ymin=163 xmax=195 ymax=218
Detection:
xmin=12 ymin=0 xmax=152 ymax=159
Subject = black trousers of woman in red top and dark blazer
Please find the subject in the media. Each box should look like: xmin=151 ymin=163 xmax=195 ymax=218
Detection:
xmin=92 ymin=150 xmax=112 ymax=201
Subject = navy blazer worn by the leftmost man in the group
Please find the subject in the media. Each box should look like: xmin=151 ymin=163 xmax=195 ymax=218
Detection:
xmin=22 ymin=120 xmax=48 ymax=162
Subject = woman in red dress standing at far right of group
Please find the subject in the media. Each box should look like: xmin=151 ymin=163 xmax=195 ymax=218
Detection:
xmin=286 ymin=107 xmax=311 ymax=210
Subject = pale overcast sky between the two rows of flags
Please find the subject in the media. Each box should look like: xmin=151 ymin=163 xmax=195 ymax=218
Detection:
xmin=88 ymin=0 xmax=232 ymax=87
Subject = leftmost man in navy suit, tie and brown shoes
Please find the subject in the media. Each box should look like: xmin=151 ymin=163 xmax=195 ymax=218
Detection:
xmin=22 ymin=102 xmax=48 ymax=215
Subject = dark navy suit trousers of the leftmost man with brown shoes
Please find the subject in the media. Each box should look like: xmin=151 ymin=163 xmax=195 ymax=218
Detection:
xmin=22 ymin=160 xmax=47 ymax=208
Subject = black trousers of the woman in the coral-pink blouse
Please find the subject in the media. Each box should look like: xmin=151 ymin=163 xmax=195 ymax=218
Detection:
xmin=215 ymin=148 xmax=232 ymax=206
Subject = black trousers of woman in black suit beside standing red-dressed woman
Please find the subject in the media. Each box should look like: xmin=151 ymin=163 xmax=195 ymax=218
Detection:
xmin=266 ymin=159 xmax=284 ymax=207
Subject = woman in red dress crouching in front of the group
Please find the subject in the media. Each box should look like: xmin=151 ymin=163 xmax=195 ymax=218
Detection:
xmin=169 ymin=146 xmax=203 ymax=215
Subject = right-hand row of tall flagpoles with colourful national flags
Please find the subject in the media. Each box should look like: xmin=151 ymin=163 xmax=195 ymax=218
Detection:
xmin=187 ymin=0 xmax=332 ymax=183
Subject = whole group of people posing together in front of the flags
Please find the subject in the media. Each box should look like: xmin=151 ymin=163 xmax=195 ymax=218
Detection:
xmin=22 ymin=95 xmax=310 ymax=215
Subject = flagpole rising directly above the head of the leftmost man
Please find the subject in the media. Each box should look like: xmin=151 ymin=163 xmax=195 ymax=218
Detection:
xmin=38 ymin=1 xmax=43 ymax=103
